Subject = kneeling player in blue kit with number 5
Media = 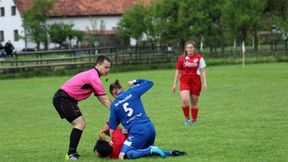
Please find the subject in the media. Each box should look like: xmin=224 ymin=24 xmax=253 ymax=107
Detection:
xmin=109 ymin=79 xmax=185 ymax=159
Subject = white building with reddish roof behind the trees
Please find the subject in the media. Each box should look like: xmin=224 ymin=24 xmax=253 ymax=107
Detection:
xmin=0 ymin=0 xmax=149 ymax=51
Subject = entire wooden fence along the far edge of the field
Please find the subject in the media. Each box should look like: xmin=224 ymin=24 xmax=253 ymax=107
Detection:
xmin=0 ymin=46 xmax=288 ymax=74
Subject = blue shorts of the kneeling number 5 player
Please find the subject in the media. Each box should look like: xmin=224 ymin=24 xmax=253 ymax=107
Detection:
xmin=121 ymin=122 xmax=156 ymax=154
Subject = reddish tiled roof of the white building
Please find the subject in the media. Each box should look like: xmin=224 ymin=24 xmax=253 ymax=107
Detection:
xmin=14 ymin=0 xmax=150 ymax=17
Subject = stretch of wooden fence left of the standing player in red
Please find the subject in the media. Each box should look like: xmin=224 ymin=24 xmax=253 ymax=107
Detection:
xmin=0 ymin=47 xmax=178 ymax=73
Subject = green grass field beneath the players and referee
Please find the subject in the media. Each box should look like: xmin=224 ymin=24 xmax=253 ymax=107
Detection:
xmin=0 ymin=63 xmax=288 ymax=162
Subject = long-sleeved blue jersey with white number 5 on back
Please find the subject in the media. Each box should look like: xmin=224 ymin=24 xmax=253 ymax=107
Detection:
xmin=109 ymin=79 xmax=153 ymax=132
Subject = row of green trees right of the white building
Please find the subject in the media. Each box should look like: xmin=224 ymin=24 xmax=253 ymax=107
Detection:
xmin=118 ymin=0 xmax=288 ymax=51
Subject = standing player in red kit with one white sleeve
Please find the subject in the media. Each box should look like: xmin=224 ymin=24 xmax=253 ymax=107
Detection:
xmin=172 ymin=41 xmax=207 ymax=125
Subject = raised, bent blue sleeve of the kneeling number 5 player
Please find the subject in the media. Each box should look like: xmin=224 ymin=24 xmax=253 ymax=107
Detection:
xmin=131 ymin=79 xmax=153 ymax=96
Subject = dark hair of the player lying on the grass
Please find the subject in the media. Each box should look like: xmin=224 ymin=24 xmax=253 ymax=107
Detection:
xmin=93 ymin=139 xmax=113 ymax=158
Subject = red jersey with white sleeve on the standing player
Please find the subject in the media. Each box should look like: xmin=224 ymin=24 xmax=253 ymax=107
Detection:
xmin=176 ymin=53 xmax=206 ymax=76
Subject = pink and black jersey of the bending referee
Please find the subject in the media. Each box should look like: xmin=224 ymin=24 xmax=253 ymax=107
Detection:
xmin=61 ymin=68 xmax=106 ymax=101
